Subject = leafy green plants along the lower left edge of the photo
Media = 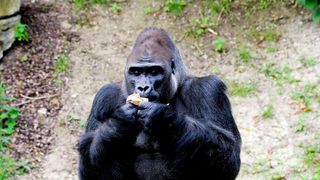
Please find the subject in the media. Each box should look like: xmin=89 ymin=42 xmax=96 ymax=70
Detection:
xmin=0 ymin=83 xmax=30 ymax=180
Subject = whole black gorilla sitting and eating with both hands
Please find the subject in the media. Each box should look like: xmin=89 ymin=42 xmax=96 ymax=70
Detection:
xmin=79 ymin=28 xmax=241 ymax=180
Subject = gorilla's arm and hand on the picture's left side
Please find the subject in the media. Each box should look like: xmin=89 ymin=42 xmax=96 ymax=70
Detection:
xmin=79 ymin=84 xmax=138 ymax=179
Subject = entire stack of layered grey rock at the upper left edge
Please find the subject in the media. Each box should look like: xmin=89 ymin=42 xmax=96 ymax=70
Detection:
xmin=0 ymin=0 xmax=21 ymax=60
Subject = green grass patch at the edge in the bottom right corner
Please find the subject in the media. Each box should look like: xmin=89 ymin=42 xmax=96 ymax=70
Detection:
xmin=304 ymin=144 xmax=320 ymax=180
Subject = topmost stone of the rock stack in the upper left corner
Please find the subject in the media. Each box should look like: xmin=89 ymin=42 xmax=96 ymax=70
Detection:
xmin=0 ymin=0 xmax=21 ymax=18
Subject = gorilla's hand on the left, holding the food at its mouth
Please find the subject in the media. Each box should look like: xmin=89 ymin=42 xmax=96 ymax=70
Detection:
xmin=112 ymin=103 xmax=138 ymax=125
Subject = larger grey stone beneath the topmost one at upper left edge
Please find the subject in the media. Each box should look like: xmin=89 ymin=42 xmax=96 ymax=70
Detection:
xmin=0 ymin=15 xmax=21 ymax=59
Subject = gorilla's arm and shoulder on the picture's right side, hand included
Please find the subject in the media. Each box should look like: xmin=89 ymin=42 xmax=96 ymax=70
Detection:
xmin=137 ymin=76 xmax=241 ymax=179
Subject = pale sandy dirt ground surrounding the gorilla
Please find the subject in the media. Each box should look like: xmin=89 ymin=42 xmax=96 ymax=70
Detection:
xmin=13 ymin=0 xmax=320 ymax=179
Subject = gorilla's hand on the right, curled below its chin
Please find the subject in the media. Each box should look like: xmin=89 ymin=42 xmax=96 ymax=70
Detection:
xmin=137 ymin=101 xmax=168 ymax=130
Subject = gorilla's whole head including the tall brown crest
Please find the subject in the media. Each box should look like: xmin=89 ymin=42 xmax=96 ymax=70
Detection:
xmin=125 ymin=28 xmax=186 ymax=103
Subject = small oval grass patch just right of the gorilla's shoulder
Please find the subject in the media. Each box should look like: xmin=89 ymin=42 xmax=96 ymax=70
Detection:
xmin=229 ymin=82 xmax=257 ymax=97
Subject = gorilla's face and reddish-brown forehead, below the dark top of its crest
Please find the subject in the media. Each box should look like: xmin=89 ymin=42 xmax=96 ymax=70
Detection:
xmin=125 ymin=36 xmax=177 ymax=103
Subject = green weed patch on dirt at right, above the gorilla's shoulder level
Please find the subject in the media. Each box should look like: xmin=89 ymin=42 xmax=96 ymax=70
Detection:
xmin=259 ymin=63 xmax=297 ymax=85
